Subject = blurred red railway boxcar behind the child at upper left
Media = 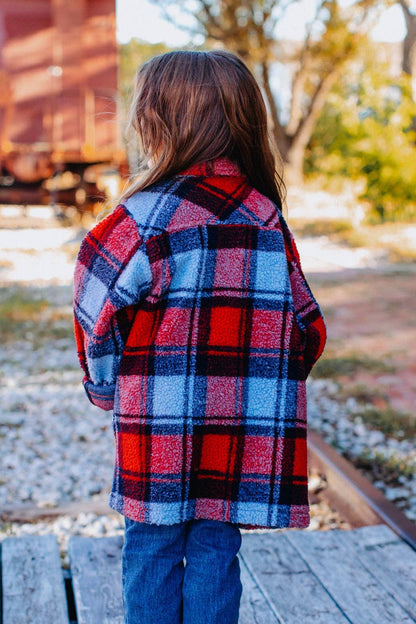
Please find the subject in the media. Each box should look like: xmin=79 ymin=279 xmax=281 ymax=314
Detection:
xmin=0 ymin=0 xmax=123 ymax=210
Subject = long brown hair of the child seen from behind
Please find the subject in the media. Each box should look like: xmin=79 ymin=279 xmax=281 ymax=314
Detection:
xmin=123 ymin=50 xmax=285 ymax=208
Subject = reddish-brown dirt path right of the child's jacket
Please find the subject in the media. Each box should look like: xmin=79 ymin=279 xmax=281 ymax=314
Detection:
xmin=308 ymin=269 xmax=416 ymax=416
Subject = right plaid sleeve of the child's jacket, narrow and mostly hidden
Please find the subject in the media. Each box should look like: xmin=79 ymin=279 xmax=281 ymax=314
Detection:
xmin=280 ymin=212 xmax=326 ymax=377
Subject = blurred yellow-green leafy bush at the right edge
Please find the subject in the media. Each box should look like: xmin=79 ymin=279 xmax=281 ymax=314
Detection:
xmin=305 ymin=43 xmax=416 ymax=222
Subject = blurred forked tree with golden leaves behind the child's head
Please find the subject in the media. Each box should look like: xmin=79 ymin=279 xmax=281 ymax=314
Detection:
xmin=153 ymin=0 xmax=374 ymax=179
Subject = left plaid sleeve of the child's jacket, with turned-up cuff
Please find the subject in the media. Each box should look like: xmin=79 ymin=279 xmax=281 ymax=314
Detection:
xmin=74 ymin=205 xmax=152 ymax=410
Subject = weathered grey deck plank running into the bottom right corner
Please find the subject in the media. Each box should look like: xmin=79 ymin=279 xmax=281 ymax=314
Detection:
xmin=287 ymin=529 xmax=414 ymax=624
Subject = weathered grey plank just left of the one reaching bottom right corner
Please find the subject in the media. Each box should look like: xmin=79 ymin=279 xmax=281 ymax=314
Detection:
xmin=240 ymin=532 xmax=350 ymax=624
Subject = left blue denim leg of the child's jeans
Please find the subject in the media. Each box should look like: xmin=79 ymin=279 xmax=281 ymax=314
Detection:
xmin=122 ymin=518 xmax=186 ymax=624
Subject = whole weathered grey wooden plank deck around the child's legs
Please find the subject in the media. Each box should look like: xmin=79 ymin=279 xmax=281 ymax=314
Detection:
xmin=2 ymin=525 xmax=416 ymax=624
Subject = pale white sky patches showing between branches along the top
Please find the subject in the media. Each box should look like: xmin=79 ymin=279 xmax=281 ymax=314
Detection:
xmin=116 ymin=0 xmax=410 ymax=47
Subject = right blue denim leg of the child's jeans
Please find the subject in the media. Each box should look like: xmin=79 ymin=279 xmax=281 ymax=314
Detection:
xmin=182 ymin=520 xmax=242 ymax=624
